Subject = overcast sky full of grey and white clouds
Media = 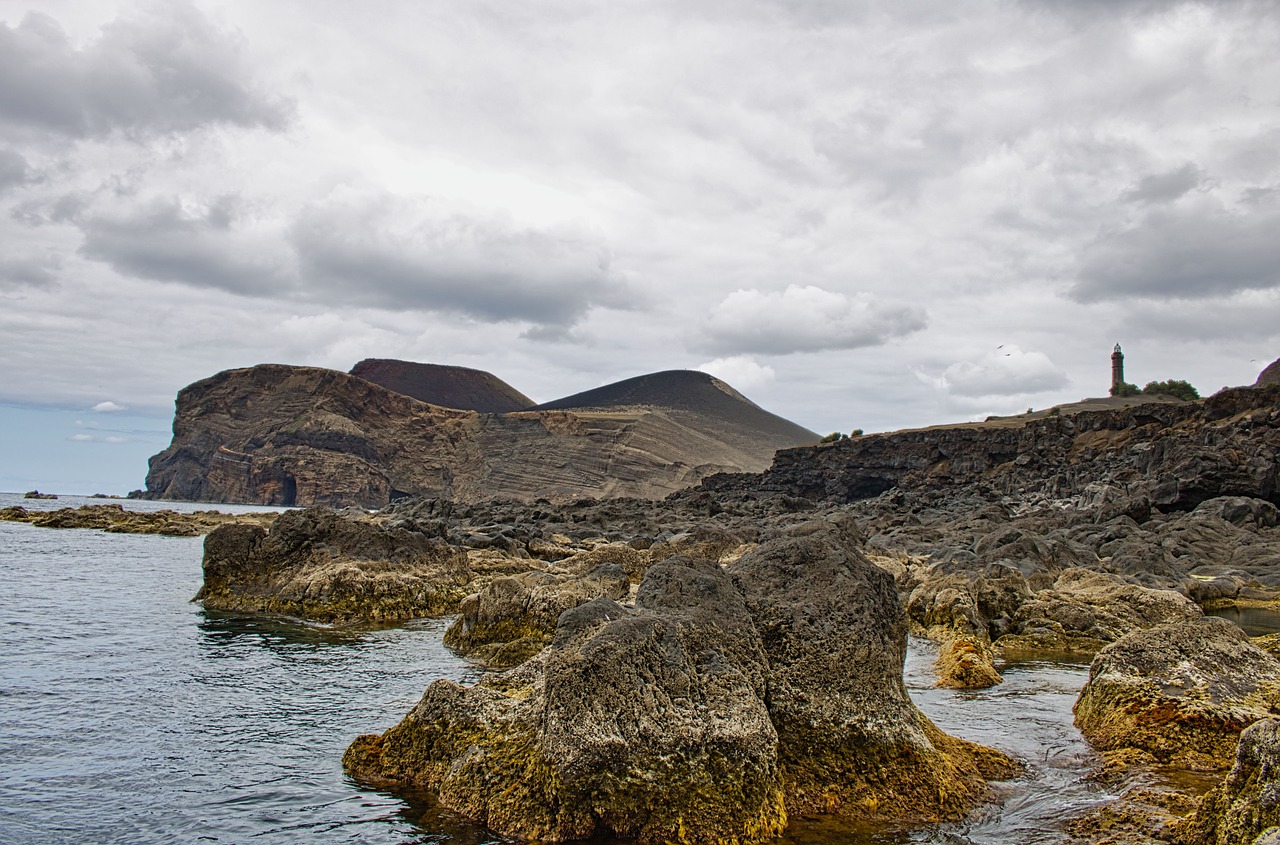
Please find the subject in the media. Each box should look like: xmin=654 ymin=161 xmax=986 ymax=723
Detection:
xmin=0 ymin=0 xmax=1280 ymax=493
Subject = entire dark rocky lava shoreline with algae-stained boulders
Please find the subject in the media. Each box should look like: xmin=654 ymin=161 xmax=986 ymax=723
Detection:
xmin=6 ymin=385 xmax=1280 ymax=845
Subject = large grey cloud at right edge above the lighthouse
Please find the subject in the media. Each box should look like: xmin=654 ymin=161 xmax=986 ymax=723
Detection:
xmin=1070 ymin=207 xmax=1280 ymax=302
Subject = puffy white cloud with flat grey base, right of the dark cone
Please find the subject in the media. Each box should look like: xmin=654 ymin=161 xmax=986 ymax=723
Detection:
xmin=705 ymin=284 xmax=927 ymax=355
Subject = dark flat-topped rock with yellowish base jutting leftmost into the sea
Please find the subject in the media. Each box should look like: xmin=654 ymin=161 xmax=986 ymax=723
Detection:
xmin=196 ymin=508 xmax=471 ymax=622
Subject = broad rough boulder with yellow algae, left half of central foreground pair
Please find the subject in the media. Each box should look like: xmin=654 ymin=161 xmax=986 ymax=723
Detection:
xmin=343 ymin=558 xmax=786 ymax=842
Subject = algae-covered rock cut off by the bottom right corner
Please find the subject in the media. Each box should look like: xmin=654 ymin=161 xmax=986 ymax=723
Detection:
xmin=1180 ymin=718 xmax=1280 ymax=845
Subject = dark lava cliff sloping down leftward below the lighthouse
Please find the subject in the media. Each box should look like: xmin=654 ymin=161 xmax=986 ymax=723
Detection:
xmin=703 ymin=385 xmax=1280 ymax=510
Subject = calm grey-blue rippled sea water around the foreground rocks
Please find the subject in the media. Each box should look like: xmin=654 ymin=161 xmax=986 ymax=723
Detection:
xmin=0 ymin=494 xmax=1106 ymax=845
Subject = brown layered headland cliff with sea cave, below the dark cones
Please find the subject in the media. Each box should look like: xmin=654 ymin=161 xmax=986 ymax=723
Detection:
xmin=146 ymin=365 xmax=815 ymax=507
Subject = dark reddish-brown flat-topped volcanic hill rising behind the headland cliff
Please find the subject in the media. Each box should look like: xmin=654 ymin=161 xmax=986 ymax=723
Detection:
xmin=351 ymin=358 xmax=534 ymax=414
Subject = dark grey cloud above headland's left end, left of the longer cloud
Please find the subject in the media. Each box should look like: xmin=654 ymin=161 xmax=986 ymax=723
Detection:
xmin=79 ymin=197 xmax=284 ymax=296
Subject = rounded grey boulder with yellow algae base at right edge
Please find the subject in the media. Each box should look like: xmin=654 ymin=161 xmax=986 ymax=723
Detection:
xmin=1075 ymin=617 xmax=1280 ymax=768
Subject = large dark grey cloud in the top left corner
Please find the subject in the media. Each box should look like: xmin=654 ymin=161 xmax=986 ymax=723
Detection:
xmin=0 ymin=1 xmax=293 ymax=137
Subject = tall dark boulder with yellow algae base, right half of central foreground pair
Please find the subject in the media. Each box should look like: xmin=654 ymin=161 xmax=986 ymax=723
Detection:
xmin=731 ymin=517 xmax=1012 ymax=821
